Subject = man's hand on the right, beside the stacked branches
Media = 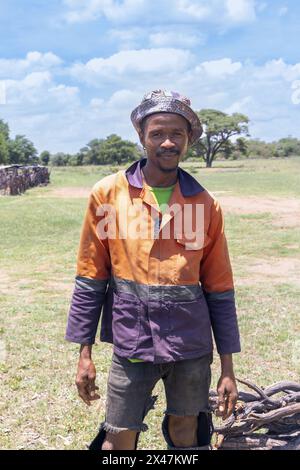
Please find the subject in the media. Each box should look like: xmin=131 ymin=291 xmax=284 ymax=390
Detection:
xmin=216 ymin=373 xmax=238 ymax=420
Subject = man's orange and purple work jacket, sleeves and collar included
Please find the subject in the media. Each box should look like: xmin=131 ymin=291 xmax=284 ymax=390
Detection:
xmin=66 ymin=159 xmax=240 ymax=363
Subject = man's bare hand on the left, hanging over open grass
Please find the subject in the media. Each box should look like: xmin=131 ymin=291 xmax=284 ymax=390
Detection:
xmin=76 ymin=346 xmax=100 ymax=406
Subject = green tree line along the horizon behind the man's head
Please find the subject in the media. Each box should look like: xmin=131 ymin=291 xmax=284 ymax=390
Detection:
xmin=0 ymin=109 xmax=300 ymax=167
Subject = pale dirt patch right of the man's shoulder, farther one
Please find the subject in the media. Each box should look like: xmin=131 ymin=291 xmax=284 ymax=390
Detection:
xmin=215 ymin=192 xmax=300 ymax=227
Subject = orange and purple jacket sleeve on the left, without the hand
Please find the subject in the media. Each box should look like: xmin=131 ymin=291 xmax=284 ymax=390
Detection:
xmin=65 ymin=187 xmax=111 ymax=344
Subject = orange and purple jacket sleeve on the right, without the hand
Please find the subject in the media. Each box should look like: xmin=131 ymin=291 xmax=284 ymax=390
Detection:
xmin=200 ymin=200 xmax=241 ymax=354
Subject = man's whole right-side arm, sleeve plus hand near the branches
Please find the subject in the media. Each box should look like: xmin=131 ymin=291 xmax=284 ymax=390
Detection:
xmin=200 ymin=201 xmax=241 ymax=419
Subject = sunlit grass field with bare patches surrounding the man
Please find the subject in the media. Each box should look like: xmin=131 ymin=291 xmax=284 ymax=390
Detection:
xmin=0 ymin=158 xmax=300 ymax=449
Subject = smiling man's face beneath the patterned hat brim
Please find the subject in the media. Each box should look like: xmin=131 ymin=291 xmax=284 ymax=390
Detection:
xmin=140 ymin=113 xmax=191 ymax=172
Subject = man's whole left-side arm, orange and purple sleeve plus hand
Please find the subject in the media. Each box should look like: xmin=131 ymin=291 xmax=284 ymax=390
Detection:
xmin=66 ymin=188 xmax=111 ymax=406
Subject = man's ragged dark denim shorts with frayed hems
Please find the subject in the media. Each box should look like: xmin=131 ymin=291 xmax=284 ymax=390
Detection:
xmin=102 ymin=353 xmax=213 ymax=433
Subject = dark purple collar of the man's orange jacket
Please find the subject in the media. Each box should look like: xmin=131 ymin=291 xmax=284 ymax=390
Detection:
xmin=125 ymin=158 xmax=205 ymax=197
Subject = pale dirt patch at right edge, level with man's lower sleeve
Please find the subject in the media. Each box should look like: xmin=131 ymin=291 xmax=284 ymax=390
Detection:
xmin=236 ymin=258 xmax=300 ymax=287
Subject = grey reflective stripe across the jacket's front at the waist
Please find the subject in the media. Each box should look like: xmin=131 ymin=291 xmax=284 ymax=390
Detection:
xmin=113 ymin=277 xmax=203 ymax=303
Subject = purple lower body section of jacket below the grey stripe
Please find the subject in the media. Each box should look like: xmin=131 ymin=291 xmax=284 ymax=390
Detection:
xmin=100 ymin=282 xmax=213 ymax=363
